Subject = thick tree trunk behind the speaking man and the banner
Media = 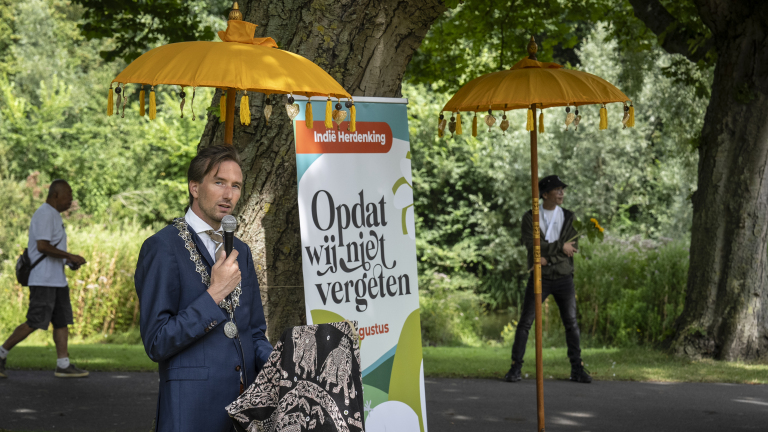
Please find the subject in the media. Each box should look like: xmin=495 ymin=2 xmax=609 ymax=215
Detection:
xmin=199 ymin=0 xmax=445 ymax=343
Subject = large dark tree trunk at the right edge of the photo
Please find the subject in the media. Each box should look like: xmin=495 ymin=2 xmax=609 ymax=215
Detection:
xmin=673 ymin=0 xmax=768 ymax=360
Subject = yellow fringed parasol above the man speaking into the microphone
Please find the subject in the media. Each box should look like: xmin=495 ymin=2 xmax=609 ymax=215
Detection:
xmin=107 ymin=2 xmax=356 ymax=144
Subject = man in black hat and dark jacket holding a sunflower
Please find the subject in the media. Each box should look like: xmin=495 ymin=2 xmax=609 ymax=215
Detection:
xmin=504 ymin=175 xmax=592 ymax=383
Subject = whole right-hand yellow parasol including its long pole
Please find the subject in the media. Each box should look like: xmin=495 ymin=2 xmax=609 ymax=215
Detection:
xmin=438 ymin=37 xmax=635 ymax=432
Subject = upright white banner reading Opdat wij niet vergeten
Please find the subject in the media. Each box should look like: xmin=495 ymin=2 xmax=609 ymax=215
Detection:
xmin=294 ymin=98 xmax=427 ymax=432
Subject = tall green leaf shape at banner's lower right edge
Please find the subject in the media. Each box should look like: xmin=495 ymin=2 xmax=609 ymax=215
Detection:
xmin=389 ymin=309 xmax=424 ymax=432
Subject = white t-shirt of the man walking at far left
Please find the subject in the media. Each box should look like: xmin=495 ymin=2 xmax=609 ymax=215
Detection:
xmin=27 ymin=203 xmax=67 ymax=288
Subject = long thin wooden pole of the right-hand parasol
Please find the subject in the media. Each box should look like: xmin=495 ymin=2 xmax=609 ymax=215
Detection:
xmin=531 ymin=104 xmax=544 ymax=432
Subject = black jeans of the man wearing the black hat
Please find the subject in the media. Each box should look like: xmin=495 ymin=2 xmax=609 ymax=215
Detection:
xmin=512 ymin=275 xmax=581 ymax=366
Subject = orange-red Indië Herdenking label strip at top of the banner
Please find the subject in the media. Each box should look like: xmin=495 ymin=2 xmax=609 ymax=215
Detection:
xmin=295 ymin=120 xmax=392 ymax=154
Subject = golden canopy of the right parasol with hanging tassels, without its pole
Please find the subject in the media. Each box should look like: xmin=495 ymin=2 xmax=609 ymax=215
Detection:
xmin=438 ymin=37 xmax=634 ymax=136
